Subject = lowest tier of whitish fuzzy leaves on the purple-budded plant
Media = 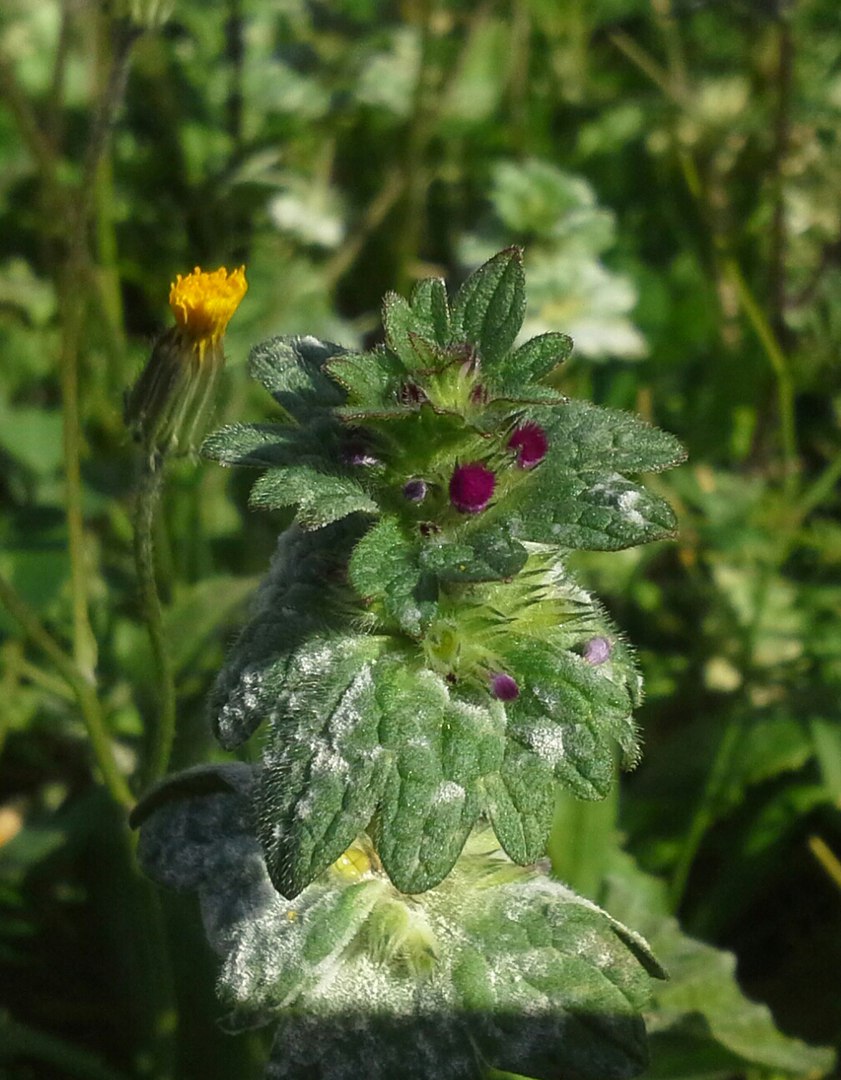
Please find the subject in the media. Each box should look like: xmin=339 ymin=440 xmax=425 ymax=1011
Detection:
xmin=134 ymin=766 xmax=663 ymax=1080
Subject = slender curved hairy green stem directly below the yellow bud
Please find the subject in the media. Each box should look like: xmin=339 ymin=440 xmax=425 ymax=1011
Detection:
xmin=134 ymin=458 xmax=176 ymax=786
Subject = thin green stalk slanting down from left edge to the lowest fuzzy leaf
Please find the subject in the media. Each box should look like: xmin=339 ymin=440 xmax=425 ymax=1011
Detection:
xmin=0 ymin=575 xmax=135 ymax=809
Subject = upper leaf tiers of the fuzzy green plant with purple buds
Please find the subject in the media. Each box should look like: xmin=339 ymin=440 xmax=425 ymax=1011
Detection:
xmin=204 ymin=248 xmax=682 ymax=897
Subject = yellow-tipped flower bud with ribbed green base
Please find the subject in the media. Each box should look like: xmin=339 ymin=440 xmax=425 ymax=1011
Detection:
xmin=125 ymin=267 xmax=248 ymax=460
